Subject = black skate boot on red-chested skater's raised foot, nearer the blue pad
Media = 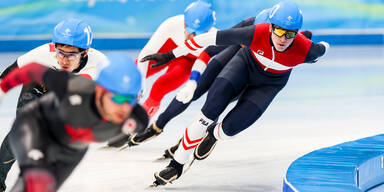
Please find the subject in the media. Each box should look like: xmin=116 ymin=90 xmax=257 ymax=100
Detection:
xmin=194 ymin=129 xmax=217 ymax=160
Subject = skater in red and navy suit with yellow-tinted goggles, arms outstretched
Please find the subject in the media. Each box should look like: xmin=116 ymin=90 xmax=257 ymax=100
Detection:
xmin=143 ymin=1 xmax=329 ymax=186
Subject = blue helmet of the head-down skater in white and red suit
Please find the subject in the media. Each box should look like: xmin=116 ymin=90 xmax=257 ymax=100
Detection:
xmin=184 ymin=0 xmax=216 ymax=35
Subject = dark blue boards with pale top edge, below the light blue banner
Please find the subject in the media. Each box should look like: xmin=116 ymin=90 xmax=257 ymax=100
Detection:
xmin=0 ymin=30 xmax=384 ymax=52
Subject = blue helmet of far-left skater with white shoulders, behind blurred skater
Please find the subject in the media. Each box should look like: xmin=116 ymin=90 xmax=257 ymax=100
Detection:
xmin=52 ymin=19 xmax=93 ymax=49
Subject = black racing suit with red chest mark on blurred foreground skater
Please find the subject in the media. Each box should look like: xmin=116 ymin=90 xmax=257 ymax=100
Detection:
xmin=3 ymin=69 xmax=148 ymax=190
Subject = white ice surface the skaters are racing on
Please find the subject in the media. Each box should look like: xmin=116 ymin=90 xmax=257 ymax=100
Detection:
xmin=0 ymin=46 xmax=384 ymax=192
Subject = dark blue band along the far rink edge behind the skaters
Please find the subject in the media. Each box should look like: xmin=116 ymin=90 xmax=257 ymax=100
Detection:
xmin=0 ymin=33 xmax=384 ymax=52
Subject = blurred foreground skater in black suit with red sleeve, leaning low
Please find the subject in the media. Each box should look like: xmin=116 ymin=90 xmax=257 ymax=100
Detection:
xmin=0 ymin=53 xmax=148 ymax=192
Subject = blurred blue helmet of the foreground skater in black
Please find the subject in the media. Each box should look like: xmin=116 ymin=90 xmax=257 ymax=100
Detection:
xmin=95 ymin=53 xmax=141 ymax=96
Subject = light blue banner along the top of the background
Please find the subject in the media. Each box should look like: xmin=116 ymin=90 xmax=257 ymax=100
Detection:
xmin=0 ymin=0 xmax=384 ymax=49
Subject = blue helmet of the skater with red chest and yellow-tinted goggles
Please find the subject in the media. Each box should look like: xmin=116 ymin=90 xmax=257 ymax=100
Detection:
xmin=269 ymin=1 xmax=303 ymax=30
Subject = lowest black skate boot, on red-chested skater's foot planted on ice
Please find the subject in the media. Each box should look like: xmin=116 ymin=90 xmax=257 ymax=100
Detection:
xmin=154 ymin=160 xmax=183 ymax=186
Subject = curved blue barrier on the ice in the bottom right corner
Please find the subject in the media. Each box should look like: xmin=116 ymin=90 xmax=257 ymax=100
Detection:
xmin=283 ymin=134 xmax=384 ymax=192
